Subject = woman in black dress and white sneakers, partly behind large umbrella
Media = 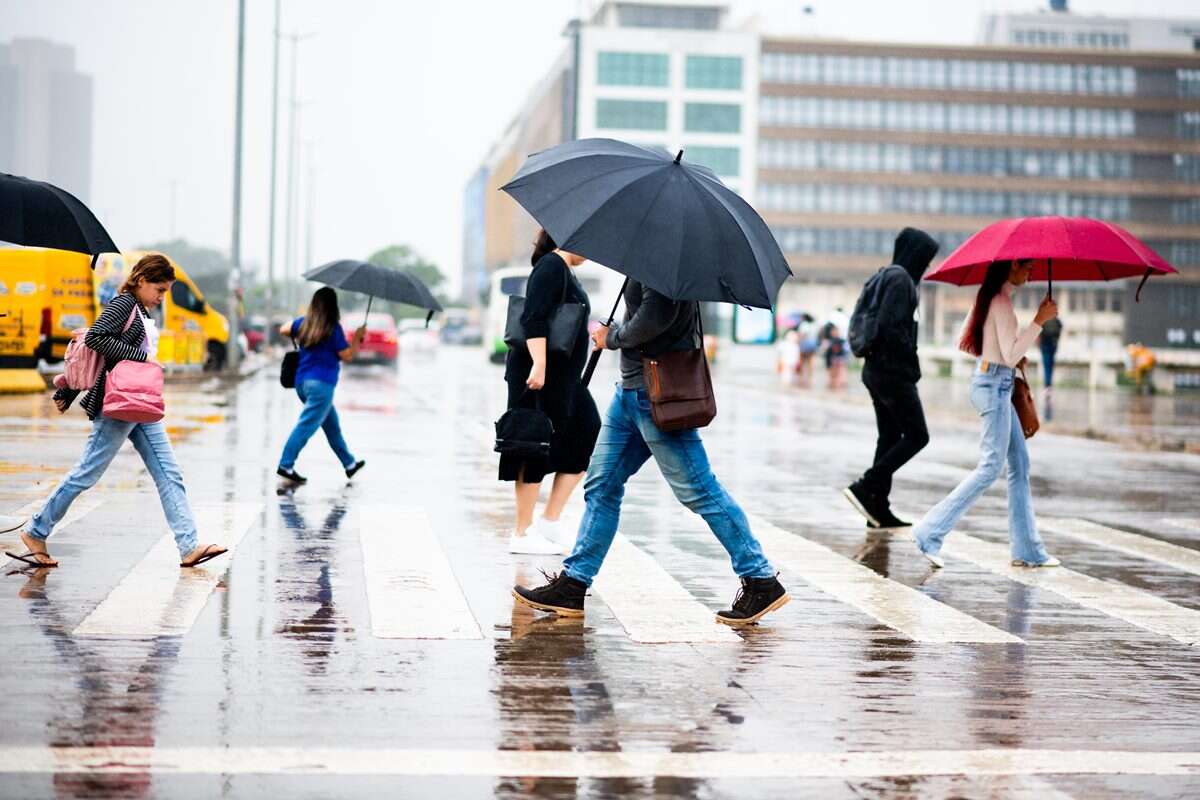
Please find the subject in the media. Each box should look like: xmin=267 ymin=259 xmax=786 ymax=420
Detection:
xmin=500 ymin=230 xmax=600 ymax=555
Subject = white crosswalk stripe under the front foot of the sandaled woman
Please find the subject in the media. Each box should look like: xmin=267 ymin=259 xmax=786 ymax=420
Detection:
xmin=72 ymin=503 xmax=263 ymax=639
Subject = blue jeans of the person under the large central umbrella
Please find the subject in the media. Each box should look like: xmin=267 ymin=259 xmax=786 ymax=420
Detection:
xmin=563 ymin=387 xmax=775 ymax=585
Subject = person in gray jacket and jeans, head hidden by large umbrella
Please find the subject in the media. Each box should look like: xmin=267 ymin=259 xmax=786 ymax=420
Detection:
xmin=512 ymin=279 xmax=790 ymax=625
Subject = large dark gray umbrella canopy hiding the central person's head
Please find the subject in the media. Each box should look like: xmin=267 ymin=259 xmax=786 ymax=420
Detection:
xmin=500 ymin=139 xmax=792 ymax=308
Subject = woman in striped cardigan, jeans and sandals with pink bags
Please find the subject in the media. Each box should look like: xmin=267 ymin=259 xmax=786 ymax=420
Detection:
xmin=8 ymin=253 xmax=227 ymax=567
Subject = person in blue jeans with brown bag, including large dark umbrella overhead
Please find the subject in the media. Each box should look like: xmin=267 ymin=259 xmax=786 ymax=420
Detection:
xmin=504 ymin=139 xmax=791 ymax=625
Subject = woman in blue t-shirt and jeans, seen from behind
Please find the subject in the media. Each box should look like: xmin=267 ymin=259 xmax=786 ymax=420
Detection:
xmin=275 ymin=287 xmax=367 ymax=483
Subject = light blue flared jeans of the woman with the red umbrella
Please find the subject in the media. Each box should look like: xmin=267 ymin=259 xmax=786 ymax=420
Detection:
xmin=912 ymin=365 xmax=1048 ymax=564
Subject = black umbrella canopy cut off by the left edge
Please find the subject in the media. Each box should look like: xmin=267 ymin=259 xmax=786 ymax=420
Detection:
xmin=0 ymin=173 xmax=120 ymax=260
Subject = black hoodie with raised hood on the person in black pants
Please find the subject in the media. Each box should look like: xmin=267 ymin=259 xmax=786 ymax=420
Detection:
xmin=864 ymin=228 xmax=937 ymax=383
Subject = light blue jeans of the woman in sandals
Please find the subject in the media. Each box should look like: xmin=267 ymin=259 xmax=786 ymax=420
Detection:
xmin=25 ymin=415 xmax=197 ymax=555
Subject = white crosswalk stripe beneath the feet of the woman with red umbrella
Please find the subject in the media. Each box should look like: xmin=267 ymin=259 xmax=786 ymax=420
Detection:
xmin=942 ymin=533 xmax=1200 ymax=644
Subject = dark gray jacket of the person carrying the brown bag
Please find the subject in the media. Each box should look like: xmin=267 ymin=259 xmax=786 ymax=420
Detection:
xmin=605 ymin=278 xmax=703 ymax=389
